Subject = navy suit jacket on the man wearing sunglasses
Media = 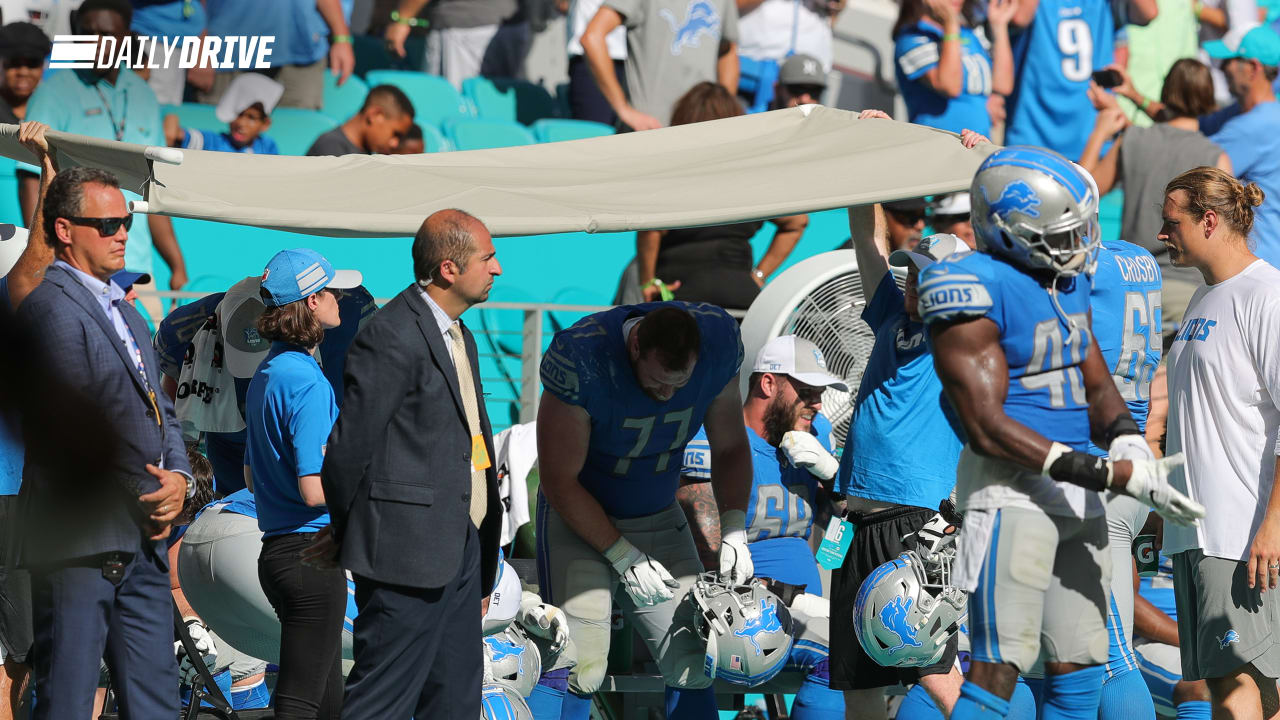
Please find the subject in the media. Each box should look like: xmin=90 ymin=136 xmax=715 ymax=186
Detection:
xmin=18 ymin=265 xmax=191 ymax=566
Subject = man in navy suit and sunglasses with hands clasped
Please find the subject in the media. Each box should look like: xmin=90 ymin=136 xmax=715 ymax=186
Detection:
xmin=18 ymin=168 xmax=195 ymax=720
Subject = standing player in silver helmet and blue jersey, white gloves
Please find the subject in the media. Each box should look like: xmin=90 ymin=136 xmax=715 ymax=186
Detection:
xmin=919 ymin=147 xmax=1203 ymax=720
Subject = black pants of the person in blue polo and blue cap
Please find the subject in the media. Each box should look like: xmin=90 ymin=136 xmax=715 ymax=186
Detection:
xmin=257 ymin=533 xmax=347 ymax=720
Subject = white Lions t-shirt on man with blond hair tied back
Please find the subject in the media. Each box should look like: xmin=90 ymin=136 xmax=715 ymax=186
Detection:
xmin=1164 ymin=260 xmax=1280 ymax=560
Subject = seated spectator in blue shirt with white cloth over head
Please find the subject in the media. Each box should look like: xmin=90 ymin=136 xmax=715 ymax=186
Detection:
xmin=164 ymin=73 xmax=284 ymax=155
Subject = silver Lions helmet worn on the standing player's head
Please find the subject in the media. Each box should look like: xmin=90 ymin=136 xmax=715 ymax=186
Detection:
xmin=969 ymin=146 xmax=1101 ymax=275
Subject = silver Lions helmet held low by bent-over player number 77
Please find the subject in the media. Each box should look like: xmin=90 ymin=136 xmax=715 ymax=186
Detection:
xmin=689 ymin=573 xmax=791 ymax=687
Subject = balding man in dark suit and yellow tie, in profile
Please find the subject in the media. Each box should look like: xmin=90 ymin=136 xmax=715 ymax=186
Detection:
xmin=322 ymin=204 xmax=502 ymax=720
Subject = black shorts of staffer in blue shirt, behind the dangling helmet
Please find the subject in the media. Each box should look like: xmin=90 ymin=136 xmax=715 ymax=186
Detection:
xmin=831 ymin=505 xmax=959 ymax=691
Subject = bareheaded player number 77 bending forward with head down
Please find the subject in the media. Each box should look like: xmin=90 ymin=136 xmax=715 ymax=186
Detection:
xmin=530 ymin=302 xmax=753 ymax=719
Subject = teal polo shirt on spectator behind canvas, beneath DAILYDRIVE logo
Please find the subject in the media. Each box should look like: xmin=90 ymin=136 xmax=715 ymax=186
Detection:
xmin=19 ymin=68 xmax=165 ymax=273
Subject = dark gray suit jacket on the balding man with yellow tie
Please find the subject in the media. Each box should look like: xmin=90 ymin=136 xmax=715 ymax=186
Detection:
xmin=321 ymin=286 xmax=502 ymax=593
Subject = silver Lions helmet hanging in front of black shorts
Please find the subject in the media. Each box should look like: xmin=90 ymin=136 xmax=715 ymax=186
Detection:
xmin=854 ymin=548 xmax=968 ymax=667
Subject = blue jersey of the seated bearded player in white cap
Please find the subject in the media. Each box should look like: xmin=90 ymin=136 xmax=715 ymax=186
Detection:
xmin=680 ymin=428 xmax=822 ymax=594
